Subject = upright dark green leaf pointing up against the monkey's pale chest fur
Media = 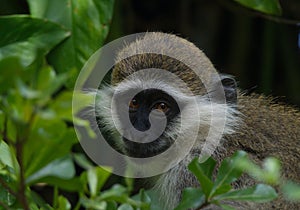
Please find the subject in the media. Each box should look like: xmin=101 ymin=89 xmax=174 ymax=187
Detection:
xmin=188 ymin=158 xmax=215 ymax=198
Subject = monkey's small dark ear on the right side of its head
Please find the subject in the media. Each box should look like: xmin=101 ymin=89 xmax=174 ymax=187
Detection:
xmin=220 ymin=74 xmax=237 ymax=104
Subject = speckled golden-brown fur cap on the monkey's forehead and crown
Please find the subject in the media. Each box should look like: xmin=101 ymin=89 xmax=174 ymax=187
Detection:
xmin=112 ymin=32 xmax=215 ymax=95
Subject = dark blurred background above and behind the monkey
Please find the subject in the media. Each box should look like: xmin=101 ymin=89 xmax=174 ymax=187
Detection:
xmin=0 ymin=0 xmax=300 ymax=105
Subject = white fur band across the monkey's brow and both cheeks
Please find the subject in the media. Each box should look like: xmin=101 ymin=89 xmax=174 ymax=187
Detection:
xmin=89 ymin=79 xmax=240 ymax=153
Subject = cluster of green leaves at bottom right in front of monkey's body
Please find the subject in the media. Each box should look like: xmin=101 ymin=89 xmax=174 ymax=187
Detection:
xmin=175 ymin=151 xmax=300 ymax=210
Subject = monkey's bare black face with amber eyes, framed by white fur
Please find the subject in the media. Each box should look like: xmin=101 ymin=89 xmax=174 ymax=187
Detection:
xmin=116 ymin=89 xmax=180 ymax=158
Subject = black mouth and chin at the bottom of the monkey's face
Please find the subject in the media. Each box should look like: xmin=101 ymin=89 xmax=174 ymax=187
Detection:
xmin=123 ymin=138 xmax=174 ymax=158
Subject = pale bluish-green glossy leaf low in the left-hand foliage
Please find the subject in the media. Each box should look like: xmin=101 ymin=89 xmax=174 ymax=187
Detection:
xmin=26 ymin=155 xmax=75 ymax=184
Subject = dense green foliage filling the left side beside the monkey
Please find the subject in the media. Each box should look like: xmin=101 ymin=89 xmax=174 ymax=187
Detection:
xmin=0 ymin=0 xmax=140 ymax=209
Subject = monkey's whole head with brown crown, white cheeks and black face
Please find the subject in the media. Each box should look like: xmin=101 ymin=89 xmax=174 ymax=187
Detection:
xmin=96 ymin=33 xmax=237 ymax=174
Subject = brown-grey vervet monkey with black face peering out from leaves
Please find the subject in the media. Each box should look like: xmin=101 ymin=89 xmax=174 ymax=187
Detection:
xmin=95 ymin=32 xmax=300 ymax=209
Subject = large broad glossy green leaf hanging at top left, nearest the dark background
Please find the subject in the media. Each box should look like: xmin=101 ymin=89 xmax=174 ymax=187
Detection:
xmin=28 ymin=0 xmax=114 ymax=85
